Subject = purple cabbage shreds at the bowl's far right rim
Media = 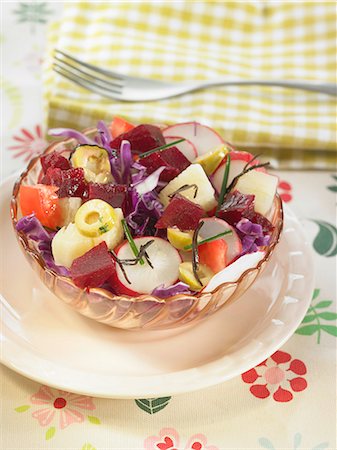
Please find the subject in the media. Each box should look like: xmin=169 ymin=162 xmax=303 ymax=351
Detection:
xmin=235 ymin=218 xmax=270 ymax=255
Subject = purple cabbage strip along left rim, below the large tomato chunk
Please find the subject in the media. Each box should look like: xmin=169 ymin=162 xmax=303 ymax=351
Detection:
xmin=16 ymin=214 xmax=69 ymax=276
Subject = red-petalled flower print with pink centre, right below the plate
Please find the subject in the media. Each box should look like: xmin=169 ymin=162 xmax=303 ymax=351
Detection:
xmin=241 ymin=350 xmax=308 ymax=403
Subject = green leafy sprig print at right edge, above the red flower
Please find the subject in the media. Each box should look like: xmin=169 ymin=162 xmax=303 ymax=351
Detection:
xmin=295 ymin=289 xmax=337 ymax=344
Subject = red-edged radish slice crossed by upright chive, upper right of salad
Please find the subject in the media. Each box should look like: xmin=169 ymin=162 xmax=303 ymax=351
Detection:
xmin=211 ymin=151 xmax=266 ymax=194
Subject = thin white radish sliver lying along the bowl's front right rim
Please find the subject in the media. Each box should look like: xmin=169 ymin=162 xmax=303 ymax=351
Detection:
xmin=203 ymin=252 xmax=265 ymax=292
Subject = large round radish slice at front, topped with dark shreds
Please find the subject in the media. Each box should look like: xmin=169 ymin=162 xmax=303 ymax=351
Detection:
xmin=114 ymin=236 xmax=181 ymax=295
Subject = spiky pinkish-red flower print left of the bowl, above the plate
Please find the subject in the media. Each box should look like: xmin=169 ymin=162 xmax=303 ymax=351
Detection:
xmin=8 ymin=125 xmax=48 ymax=161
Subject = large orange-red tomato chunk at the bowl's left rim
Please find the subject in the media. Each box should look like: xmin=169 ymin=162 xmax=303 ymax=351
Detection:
xmin=19 ymin=184 xmax=62 ymax=229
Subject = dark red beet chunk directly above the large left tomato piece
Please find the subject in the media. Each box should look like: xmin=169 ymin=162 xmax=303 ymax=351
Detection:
xmin=41 ymin=167 xmax=88 ymax=198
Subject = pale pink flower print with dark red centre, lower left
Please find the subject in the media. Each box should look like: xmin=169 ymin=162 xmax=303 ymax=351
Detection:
xmin=31 ymin=386 xmax=96 ymax=430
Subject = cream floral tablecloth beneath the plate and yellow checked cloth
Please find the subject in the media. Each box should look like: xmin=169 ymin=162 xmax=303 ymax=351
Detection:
xmin=0 ymin=2 xmax=337 ymax=450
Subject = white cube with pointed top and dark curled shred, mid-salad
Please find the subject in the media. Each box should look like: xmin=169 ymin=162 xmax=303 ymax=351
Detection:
xmin=159 ymin=164 xmax=217 ymax=211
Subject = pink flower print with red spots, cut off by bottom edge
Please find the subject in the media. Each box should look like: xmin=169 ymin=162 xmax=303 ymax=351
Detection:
xmin=144 ymin=428 xmax=219 ymax=450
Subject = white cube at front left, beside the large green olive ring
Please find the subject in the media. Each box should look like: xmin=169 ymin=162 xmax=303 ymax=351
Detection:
xmin=51 ymin=223 xmax=95 ymax=268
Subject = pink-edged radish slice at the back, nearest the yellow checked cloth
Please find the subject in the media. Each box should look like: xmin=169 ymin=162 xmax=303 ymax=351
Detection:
xmin=163 ymin=122 xmax=225 ymax=156
